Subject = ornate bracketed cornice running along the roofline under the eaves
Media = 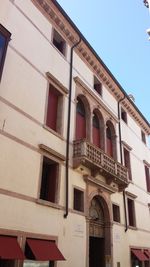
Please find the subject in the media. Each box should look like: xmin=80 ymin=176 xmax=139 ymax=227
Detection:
xmin=31 ymin=0 xmax=150 ymax=134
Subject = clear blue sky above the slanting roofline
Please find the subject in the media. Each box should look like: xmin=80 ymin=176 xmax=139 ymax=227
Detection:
xmin=58 ymin=0 xmax=150 ymax=122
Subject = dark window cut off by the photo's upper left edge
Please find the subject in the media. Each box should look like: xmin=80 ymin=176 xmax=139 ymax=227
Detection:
xmin=0 ymin=24 xmax=11 ymax=79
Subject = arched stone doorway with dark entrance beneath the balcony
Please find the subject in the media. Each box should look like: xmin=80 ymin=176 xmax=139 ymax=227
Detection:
xmin=89 ymin=195 xmax=111 ymax=267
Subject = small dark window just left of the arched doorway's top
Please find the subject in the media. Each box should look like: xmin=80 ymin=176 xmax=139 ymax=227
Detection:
xmin=73 ymin=188 xmax=84 ymax=212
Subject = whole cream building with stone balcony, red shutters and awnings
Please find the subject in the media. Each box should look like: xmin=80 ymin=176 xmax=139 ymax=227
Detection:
xmin=0 ymin=0 xmax=150 ymax=267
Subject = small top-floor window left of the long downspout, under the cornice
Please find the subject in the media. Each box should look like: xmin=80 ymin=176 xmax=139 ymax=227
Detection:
xmin=53 ymin=29 xmax=66 ymax=56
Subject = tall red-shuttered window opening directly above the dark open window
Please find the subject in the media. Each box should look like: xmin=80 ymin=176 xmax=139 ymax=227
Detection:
xmin=46 ymin=84 xmax=63 ymax=133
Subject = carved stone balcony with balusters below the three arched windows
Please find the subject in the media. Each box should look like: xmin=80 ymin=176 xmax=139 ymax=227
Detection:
xmin=73 ymin=139 xmax=128 ymax=191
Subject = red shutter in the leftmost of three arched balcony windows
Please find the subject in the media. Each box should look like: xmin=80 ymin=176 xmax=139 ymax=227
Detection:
xmin=76 ymin=112 xmax=86 ymax=140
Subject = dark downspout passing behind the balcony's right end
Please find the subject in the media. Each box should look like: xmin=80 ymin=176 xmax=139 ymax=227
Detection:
xmin=118 ymin=95 xmax=128 ymax=232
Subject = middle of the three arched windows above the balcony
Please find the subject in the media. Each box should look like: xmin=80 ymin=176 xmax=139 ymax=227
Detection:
xmin=92 ymin=113 xmax=100 ymax=147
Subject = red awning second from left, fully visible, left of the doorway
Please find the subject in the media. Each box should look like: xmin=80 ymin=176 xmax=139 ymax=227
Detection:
xmin=27 ymin=238 xmax=65 ymax=261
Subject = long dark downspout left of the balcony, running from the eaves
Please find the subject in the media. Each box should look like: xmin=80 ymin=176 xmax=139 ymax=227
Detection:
xmin=64 ymin=37 xmax=81 ymax=218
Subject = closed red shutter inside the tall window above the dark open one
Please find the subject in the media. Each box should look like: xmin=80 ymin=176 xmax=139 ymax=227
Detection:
xmin=46 ymin=85 xmax=59 ymax=131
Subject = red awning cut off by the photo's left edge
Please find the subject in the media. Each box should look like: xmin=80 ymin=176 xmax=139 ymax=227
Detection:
xmin=0 ymin=236 xmax=25 ymax=260
